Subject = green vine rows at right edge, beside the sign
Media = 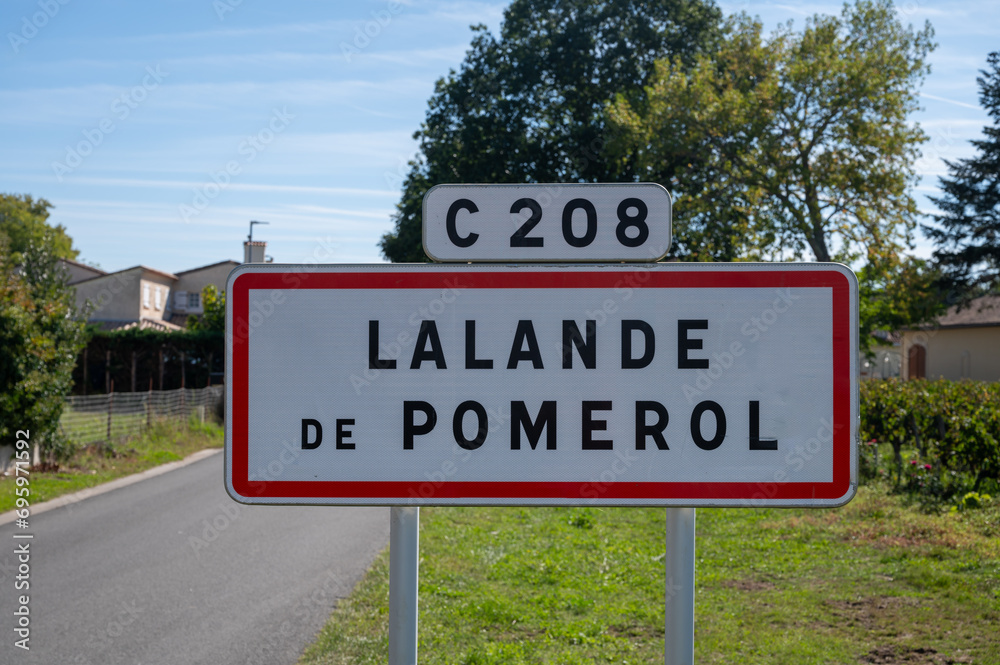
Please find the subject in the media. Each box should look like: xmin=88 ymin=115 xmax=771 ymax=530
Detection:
xmin=860 ymin=379 xmax=1000 ymax=505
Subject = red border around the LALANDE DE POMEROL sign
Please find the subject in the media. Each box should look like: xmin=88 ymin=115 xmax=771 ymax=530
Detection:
xmin=226 ymin=264 xmax=856 ymax=505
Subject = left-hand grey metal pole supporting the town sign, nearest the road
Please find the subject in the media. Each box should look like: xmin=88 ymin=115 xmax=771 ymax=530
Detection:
xmin=389 ymin=506 xmax=420 ymax=665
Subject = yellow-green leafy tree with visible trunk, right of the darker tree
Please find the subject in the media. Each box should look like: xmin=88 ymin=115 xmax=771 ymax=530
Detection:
xmin=609 ymin=0 xmax=933 ymax=264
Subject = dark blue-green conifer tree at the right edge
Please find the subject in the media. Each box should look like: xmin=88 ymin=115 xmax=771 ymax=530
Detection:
xmin=924 ymin=51 xmax=1000 ymax=296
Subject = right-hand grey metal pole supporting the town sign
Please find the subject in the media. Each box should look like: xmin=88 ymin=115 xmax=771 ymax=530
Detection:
xmin=664 ymin=508 xmax=695 ymax=665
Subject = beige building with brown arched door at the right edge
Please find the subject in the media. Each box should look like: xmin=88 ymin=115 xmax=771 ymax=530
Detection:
xmin=901 ymin=296 xmax=1000 ymax=381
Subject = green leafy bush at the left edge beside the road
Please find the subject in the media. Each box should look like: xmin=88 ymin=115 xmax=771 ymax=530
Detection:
xmin=0 ymin=228 xmax=86 ymax=463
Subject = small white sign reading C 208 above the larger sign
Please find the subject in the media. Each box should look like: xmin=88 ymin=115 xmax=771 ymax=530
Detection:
xmin=423 ymin=183 xmax=670 ymax=263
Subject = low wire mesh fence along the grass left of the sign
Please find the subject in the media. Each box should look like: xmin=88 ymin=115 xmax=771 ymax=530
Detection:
xmin=59 ymin=386 xmax=223 ymax=445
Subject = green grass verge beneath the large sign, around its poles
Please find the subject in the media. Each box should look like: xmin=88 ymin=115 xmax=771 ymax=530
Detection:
xmin=301 ymin=487 xmax=1000 ymax=665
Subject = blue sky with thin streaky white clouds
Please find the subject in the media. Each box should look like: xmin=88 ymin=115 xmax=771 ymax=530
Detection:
xmin=0 ymin=0 xmax=1000 ymax=272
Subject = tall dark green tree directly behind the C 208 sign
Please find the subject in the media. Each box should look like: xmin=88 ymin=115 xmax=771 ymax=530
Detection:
xmin=380 ymin=0 xmax=721 ymax=261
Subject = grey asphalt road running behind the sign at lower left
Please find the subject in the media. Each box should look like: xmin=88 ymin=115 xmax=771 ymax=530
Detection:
xmin=0 ymin=454 xmax=389 ymax=665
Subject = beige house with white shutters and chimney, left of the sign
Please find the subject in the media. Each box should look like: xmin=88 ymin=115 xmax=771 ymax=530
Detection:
xmin=62 ymin=241 xmax=267 ymax=331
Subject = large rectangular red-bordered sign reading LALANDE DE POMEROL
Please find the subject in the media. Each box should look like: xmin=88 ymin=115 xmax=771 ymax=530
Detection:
xmin=226 ymin=263 xmax=858 ymax=506
